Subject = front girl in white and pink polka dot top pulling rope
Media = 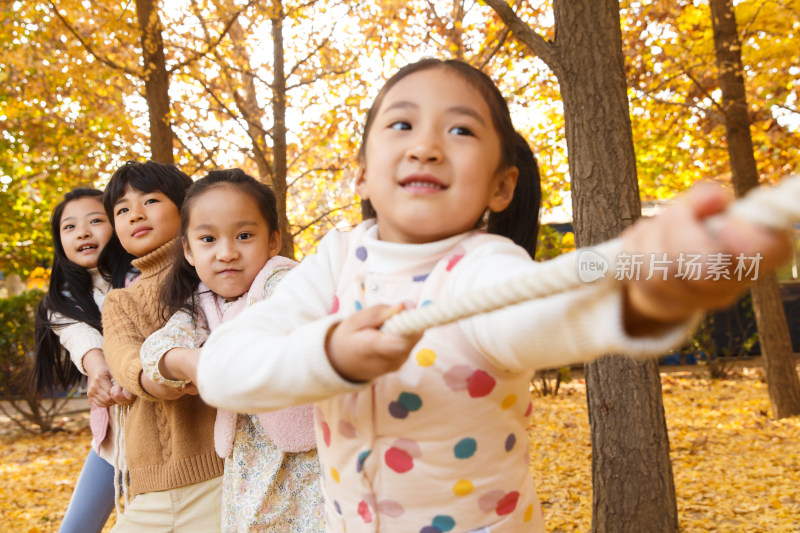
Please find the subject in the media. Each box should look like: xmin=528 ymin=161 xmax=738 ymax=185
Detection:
xmin=197 ymin=60 xmax=789 ymax=533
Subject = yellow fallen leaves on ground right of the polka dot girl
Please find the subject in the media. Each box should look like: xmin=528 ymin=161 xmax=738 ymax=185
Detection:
xmin=529 ymin=372 xmax=800 ymax=532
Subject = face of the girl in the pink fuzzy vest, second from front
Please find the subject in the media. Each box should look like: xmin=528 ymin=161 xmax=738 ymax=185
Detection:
xmin=183 ymin=185 xmax=281 ymax=299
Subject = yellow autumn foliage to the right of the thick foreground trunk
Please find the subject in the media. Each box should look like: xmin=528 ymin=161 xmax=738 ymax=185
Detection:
xmin=621 ymin=0 xmax=800 ymax=196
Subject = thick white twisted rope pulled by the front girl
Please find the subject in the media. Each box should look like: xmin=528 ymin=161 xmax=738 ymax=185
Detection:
xmin=381 ymin=175 xmax=800 ymax=335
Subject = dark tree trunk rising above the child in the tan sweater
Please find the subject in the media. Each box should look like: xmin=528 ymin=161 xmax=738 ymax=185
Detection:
xmin=136 ymin=0 xmax=175 ymax=165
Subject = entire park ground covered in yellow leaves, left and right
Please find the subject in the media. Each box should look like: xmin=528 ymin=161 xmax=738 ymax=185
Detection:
xmin=0 ymin=366 xmax=800 ymax=533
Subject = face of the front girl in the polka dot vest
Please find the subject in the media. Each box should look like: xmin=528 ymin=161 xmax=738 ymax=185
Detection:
xmin=356 ymin=67 xmax=518 ymax=243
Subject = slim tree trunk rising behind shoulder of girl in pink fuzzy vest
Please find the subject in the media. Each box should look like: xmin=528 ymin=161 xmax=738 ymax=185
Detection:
xmin=271 ymin=0 xmax=294 ymax=259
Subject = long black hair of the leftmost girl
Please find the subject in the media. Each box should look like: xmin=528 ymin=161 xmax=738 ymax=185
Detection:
xmin=33 ymin=188 xmax=106 ymax=392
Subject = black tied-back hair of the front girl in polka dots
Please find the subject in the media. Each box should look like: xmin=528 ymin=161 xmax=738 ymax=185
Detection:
xmin=358 ymin=59 xmax=542 ymax=257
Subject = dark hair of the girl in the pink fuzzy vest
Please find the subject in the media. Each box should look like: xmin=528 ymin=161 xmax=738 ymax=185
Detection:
xmin=158 ymin=168 xmax=279 ymax=323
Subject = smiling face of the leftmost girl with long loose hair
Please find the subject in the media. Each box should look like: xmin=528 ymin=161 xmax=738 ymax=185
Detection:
xmin=58 ymin=196 xmax=114 ymax=268
